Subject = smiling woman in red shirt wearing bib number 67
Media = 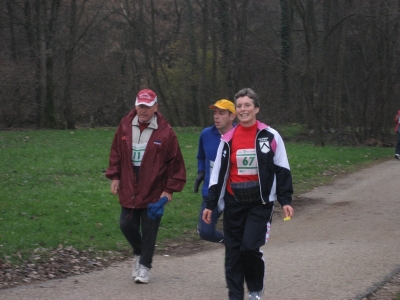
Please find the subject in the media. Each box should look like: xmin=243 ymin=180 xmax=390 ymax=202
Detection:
xmin=203 ymin=88 xmax=293 ymax=300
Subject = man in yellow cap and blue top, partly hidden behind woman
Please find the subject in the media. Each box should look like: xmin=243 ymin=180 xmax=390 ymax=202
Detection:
xmin=194 ymin=99 xmax=236 ymax=243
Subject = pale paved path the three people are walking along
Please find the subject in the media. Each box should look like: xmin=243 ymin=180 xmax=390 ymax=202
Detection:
xmin=0 ymin=160 xmax=400 ymax=300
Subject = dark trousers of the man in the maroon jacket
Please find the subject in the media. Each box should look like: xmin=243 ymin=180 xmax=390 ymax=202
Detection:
xmin=119 ymin=207 xmax=161 ymax=268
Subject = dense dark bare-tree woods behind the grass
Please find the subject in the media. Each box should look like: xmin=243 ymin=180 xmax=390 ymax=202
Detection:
xmin=0 ymin=0 xmax=400 ymax=145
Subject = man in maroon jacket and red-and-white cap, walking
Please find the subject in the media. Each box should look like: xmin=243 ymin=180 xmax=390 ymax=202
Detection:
xmin=106 ymin=89 xmax=186 ymax=283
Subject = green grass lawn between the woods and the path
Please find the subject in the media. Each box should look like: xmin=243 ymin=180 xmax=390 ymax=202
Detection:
xmin=0 ymin=128 xmax=393 ymax=262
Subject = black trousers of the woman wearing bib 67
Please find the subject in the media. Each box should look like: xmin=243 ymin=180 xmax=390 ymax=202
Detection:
xmin=224 ymin=192 xmax=273 ymax=300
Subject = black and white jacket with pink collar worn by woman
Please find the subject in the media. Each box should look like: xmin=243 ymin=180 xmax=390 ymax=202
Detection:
xmin=206 ymin=121 xmax=293 ymax=211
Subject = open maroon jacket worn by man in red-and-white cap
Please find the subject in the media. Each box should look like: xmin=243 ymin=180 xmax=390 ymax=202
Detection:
xmin=106 ymin=109 xmax=186 ymax=208
